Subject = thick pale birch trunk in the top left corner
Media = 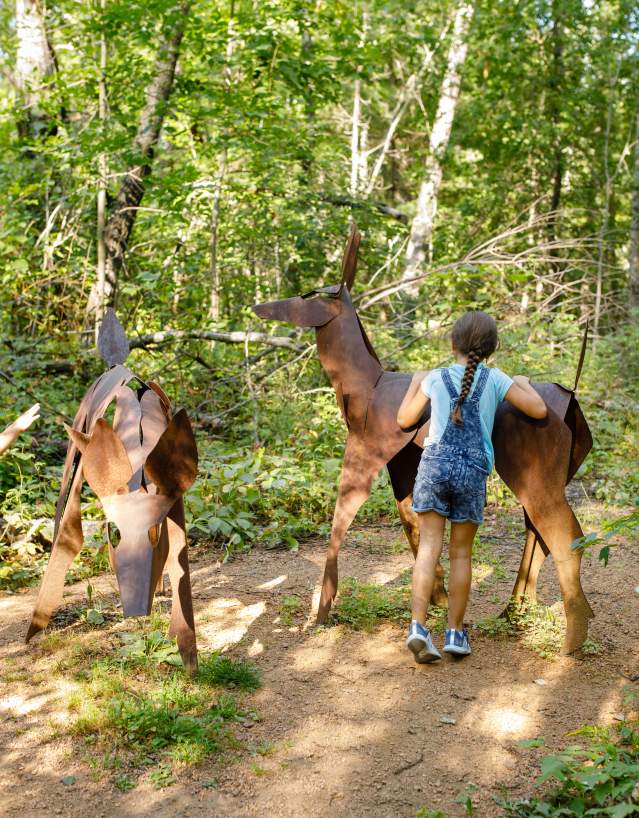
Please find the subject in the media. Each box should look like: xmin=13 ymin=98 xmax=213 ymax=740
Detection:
xmin=15 ymin=0 xmax=56 ymax=138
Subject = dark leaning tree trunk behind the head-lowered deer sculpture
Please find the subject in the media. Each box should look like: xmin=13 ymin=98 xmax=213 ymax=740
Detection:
xmin=87 ymin=2 xmax=190 ymax=313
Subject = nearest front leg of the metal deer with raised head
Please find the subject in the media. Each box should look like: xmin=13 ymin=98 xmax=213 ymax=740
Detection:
xmin=317 ymin=441 xmax=381 ymax=625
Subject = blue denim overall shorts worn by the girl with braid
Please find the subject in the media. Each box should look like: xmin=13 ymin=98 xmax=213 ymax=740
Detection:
xmin=413 ymin=367 xmax=490 ymax=525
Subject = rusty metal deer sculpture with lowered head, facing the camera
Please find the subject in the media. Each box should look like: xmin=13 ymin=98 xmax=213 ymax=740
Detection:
xmin=27 ymin=310 xmax=197 ymax=673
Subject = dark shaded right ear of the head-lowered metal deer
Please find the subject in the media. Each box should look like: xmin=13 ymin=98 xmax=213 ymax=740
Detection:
xmin=144 ymin=409 xmax=197 ymax=497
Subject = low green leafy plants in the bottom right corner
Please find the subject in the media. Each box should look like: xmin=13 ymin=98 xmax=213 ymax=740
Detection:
xmin=501 ymin=724 xmax=639 ymax=818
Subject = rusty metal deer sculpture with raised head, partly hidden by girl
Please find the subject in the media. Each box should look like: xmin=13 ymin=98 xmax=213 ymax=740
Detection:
xmin=253 ymin=222 xmax=594 ymax=653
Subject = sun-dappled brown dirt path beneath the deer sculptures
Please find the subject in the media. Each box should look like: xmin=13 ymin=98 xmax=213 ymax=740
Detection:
xmin=0 ymin=490 xmax=639 ymax=818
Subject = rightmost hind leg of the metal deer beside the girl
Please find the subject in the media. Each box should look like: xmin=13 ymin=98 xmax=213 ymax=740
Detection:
xmin=526 ymin=491 xmax=594 ymax=654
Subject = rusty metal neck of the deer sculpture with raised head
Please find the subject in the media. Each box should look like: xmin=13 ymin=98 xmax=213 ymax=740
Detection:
xmin=316 ymin=289 xmax=384 ymax=395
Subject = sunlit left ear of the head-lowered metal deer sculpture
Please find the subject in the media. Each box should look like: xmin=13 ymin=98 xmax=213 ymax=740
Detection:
xmin=66 ymin=418 xmax=133 ymax=497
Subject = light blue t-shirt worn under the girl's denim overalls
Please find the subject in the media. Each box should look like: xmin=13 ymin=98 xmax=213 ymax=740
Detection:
xmin=422 ymin=363 xmax=513 ymax=471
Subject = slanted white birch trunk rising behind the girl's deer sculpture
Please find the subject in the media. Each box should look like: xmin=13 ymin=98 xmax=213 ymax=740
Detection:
xmin=402 ymin=2 xmax=474 ymax=295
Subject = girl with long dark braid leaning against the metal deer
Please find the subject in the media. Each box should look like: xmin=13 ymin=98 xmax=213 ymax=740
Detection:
xmin=397 ymin=310 xmax=546 ymax=663
